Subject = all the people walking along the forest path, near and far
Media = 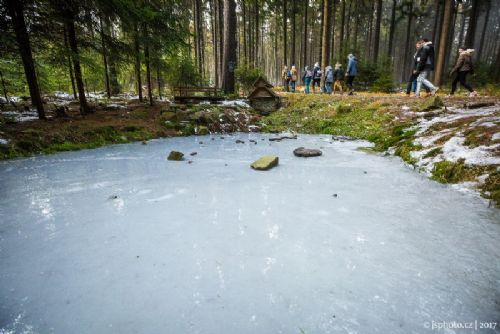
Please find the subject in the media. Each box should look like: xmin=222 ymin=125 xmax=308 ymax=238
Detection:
xmin=282 ymin=38 xmax=477 ymax=97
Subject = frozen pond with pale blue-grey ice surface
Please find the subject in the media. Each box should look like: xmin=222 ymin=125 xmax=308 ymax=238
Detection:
xmin=0 ymin=134 xmax=500 ymax=334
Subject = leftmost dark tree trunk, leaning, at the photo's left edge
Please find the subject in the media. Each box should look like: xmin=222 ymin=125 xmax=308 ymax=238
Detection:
xmin=5 ymin=0 xmax=45 ymax=119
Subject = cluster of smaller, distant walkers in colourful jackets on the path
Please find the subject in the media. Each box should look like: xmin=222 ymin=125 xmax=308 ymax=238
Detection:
xmin=281 ymin=54 xmax=358 ymax=94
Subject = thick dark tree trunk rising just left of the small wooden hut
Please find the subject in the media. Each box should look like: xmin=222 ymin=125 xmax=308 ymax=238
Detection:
xmin=222 ymin=0 xmax=237 ymax=94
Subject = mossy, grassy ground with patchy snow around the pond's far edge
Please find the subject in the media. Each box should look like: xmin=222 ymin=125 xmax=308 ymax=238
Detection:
xmin=0 ymin=93 xmax=500 ymax=205
